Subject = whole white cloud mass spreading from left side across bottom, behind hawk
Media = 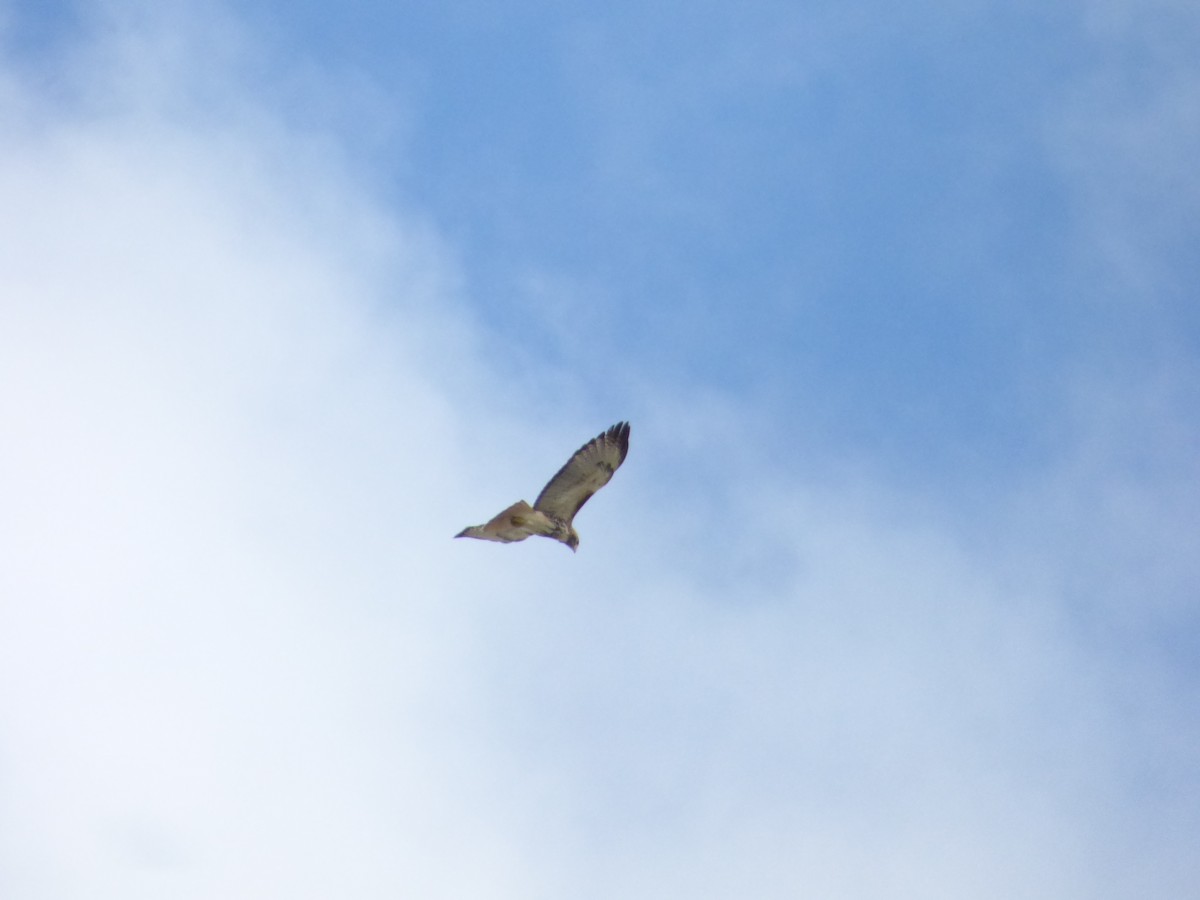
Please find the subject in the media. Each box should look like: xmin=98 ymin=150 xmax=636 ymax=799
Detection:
xmin=0 ymin=3 xmax=1198 ymax=898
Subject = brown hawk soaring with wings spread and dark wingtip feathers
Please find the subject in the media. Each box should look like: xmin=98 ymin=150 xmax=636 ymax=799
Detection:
xmin=455 ymin=422 xmax=629 ymax=551
